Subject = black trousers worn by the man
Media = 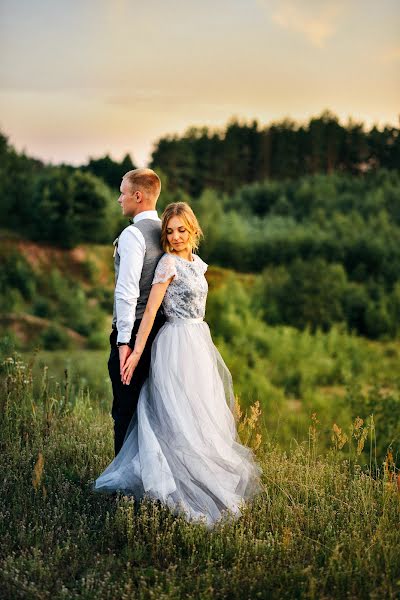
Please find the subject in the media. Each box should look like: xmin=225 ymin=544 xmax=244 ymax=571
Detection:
xmin=108 ymin=314 xmax=165 ymax=456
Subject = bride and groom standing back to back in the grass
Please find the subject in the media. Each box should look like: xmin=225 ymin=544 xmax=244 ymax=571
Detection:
xmin=94 ymin=169 xmax=260 ymax=526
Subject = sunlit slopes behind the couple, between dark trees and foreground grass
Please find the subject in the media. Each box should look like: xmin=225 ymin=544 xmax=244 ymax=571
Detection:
xmin=0 ymin=234 xmax=400 ymax=460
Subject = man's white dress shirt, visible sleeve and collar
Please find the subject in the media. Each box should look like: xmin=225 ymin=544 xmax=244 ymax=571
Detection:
xmin=115 ymin=210 xmax=161 ymax=343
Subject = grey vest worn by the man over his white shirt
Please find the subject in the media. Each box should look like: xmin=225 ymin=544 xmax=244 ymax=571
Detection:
xmin=113 ymin=219 xmax=164 ymax=327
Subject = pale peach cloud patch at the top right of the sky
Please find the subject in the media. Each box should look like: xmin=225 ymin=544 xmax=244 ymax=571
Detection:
xmin=258 ymin=0 xmax=346 ymax=48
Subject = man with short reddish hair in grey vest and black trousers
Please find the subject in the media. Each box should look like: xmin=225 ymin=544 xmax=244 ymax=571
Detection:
xmin=108 ymin=169 xmax=165 ymax=455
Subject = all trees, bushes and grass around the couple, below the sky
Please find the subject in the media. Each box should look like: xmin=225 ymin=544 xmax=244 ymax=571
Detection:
xmin=0 ymin=111 xmax=400 ymax=600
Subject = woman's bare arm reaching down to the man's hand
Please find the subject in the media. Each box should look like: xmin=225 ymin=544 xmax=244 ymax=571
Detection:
xmin=121 ymin=277 xmax=173 ymax=385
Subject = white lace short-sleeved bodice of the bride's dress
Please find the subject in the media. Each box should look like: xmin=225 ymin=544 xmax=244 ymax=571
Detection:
xmin=153 ymin=254 xmax=208 ymax=319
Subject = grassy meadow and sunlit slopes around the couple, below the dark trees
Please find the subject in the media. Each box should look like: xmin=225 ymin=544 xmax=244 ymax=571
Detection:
xmin=0 ymin=237 xmax=400 ymax=600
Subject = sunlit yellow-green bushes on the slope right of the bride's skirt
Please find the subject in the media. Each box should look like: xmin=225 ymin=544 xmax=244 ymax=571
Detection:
xmin=206 ymin=276 xmax=400 ymax=460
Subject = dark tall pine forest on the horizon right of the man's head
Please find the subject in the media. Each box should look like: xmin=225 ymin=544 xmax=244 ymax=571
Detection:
xmin=151 ymin=111 xmax=400 ymax=197
